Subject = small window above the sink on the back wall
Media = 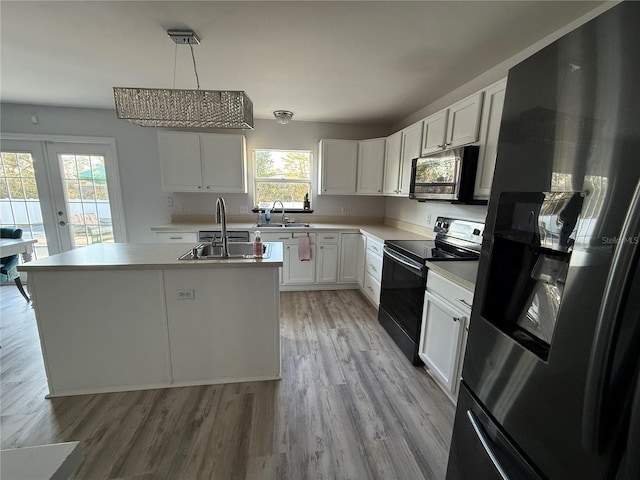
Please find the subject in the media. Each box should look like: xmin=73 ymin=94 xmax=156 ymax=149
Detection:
xmin=253 ymin=150 xmax=311 ymax=210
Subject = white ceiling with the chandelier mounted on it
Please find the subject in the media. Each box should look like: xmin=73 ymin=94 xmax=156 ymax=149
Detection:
xmin=0 ymin=0 xmax=601 ymax=125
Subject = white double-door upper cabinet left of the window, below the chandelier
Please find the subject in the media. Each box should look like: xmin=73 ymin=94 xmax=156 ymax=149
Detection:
xmin=158 ymin=130 xmax=247 ymax=193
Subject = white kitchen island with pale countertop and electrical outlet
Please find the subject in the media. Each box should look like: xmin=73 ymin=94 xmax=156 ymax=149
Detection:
xmin=19 ymin=243 xmax=282 ymax=397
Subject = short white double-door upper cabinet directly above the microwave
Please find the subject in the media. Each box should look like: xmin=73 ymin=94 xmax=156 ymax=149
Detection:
xmin=421 ymin=92 xmax=483 ymax=155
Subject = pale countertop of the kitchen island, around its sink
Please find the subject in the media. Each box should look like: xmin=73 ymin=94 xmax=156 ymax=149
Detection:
xmin=18 ymin=242 xmax=283 ymax=272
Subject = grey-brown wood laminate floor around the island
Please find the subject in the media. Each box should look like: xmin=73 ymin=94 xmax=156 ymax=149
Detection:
xmin=0 ymin=285 xmax=454 ymax=480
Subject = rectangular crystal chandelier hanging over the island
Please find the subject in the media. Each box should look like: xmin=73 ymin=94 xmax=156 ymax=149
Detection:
xmin=113 ymin=30 xmax=253 ymax=129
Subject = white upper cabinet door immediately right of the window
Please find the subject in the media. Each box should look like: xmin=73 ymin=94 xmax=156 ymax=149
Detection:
xmin=319 ymin=138 xmax=358 ymax=195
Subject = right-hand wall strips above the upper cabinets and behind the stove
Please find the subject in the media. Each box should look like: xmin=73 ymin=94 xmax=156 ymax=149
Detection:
xmin=385 ymin=1 xmax=619 ymax=226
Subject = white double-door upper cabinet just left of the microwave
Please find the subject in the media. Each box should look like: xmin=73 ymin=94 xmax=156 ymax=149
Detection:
xmin=383 ymin=122 xmax=423 ymax=196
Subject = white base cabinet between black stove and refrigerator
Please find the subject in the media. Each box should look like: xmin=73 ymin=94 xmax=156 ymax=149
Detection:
xmin=418 ymin=270 xmax=473 ymax=401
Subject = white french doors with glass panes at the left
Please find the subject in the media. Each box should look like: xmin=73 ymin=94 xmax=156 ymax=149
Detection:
xmin=0 ymin=139 xmax=126 ymax=258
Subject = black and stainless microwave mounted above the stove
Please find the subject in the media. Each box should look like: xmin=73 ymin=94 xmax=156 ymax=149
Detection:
xmin=409 ymin=145 xmax=479 ymax=203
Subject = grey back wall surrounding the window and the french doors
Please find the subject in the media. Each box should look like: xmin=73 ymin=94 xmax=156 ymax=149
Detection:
xmin=0 ymin=104 xmax=387 ymax=242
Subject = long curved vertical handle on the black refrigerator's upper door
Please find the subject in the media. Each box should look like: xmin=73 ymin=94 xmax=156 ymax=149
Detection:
xmin=582 ymin=178 xmax=640 ymax=453
